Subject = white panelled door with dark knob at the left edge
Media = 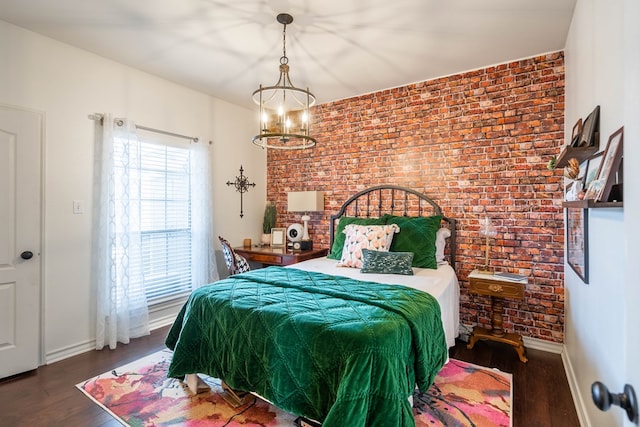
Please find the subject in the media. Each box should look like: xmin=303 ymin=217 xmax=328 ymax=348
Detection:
xmin=0 ymin=105 xmax=42 ymax=378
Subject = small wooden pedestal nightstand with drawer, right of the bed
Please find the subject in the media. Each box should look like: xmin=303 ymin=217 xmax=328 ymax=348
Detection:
xmin=467 ymin=270 xmax=527 ymax=363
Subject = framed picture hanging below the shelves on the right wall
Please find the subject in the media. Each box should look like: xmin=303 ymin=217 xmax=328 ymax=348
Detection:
xmin=565 ymin=208 xmax=589 ymax=284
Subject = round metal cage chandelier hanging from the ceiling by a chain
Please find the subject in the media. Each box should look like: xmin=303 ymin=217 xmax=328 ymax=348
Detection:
xmin=252 ymin=13 xmax=316 ymax=150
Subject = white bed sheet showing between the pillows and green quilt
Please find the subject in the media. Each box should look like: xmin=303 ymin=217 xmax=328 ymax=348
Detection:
xmin=288 ymin=257 xmax=460 ymax=347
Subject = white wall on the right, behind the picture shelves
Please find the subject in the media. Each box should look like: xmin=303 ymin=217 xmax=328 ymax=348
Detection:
xmin=564 ymin=0 xmax=640 ymax=426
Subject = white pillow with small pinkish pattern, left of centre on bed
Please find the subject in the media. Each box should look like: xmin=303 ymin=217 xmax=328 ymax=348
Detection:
xmin=338 ymin=224 xmax=400 ymax=268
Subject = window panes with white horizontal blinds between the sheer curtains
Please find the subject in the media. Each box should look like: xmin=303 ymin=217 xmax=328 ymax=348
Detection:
xmin=139 ymin=142 xmax=192 ymax=305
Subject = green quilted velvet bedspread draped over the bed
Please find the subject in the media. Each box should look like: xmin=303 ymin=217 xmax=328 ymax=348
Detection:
xmin=166 ymin=267 xmax=447 ymax=427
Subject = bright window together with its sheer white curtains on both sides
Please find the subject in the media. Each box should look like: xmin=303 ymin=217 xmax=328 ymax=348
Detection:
xmin=91 ymin=113 xmax=218 ymax=349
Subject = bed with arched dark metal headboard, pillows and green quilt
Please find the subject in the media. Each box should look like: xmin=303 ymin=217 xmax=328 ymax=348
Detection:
xmin=166 ymin=186 xmax=459 ymax=427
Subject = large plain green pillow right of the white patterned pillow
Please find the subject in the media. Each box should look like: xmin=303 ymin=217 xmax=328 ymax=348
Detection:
xmin=387 ymin=215 xmax=442 ymax=269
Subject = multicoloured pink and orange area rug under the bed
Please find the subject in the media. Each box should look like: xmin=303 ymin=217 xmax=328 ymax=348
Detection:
xmin=76 ymin=350 xmax=512 ymax=427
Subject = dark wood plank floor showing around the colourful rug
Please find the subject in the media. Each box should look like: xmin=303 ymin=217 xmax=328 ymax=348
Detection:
xmin=0 ymin=328 xmax=580 ymax=427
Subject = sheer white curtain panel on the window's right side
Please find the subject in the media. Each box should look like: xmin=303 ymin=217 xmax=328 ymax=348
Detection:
xmin=190 ymin=142 xmax=219 ymax=289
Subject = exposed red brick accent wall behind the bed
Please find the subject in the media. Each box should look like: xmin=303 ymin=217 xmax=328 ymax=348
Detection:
xmin=267 ymin=52 xmax=564 ymax=342
